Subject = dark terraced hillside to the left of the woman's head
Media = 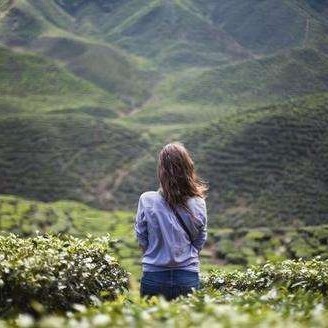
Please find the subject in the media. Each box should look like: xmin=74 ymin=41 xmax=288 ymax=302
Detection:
xmin=0 ymin=114 xmax=148 ymax=208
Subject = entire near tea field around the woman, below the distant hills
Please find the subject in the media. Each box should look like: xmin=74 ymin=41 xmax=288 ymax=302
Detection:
xmin=0 ymin=196 xmax=328 ymax=327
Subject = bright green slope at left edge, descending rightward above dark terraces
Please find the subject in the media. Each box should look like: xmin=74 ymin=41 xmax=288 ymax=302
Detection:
xmin=0 ymin=47 xmax=124 ymax=119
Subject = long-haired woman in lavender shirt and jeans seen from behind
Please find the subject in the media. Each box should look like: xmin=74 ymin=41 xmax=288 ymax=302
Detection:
xmin=135 ymin=142 xmax=208 ymax=300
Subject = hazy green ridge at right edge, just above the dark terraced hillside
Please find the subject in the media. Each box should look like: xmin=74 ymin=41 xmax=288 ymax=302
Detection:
xmin=156 ymin=49 xmax=328 ymax=108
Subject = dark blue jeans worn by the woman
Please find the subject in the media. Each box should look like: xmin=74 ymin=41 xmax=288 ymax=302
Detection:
xmin=140 ymin=269 xmax=200 ymax=301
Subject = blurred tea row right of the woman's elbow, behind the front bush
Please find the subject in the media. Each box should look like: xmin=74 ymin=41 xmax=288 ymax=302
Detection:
xmin=209 ymin=225 xmax=328 ymax=265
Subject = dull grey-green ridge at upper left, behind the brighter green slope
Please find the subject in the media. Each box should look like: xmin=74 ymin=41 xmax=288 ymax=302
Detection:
xmin=28 ymin=37 xmax=157 ymax=108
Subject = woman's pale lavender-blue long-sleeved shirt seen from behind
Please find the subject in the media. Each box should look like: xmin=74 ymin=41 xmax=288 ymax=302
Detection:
xmin=135 ymin=191 xmax=207 ymax=272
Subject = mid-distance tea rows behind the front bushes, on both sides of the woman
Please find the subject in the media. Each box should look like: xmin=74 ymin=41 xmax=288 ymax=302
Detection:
xmin=0 ymin=196 xmax=328 ymax=285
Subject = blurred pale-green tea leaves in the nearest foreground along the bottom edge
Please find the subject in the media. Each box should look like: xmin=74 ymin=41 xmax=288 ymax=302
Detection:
xmin=3 ymin=289 xmax=328 ymax=328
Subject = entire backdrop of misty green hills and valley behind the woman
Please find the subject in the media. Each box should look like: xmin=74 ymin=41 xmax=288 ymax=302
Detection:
xmin=0 ymin=0 xmax=328 ymax=226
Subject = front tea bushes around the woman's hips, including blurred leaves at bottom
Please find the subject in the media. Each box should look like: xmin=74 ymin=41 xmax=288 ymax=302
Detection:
xmin=0 ymin=235 xmax=328 ymax=327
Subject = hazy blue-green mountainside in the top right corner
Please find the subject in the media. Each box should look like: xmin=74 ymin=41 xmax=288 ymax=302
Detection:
xmin=195 ymin=0 xmax=327 ymax=54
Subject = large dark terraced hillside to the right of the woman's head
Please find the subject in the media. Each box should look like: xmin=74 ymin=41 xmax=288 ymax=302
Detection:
xmin=183 ymin=94 xmax=328 ymax=228
